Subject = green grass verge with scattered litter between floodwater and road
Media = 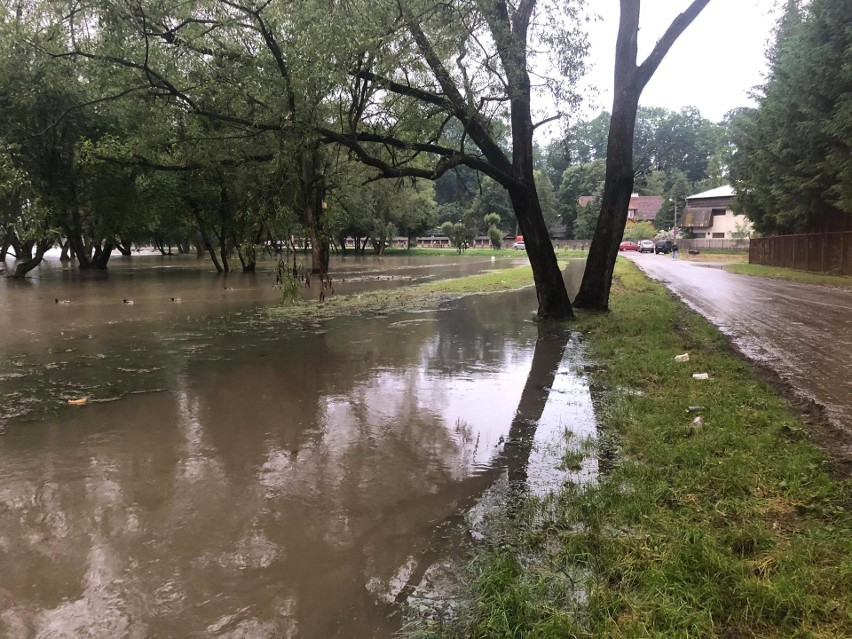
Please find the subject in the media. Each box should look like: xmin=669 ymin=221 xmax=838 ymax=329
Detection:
xmin=407 ymin=260 xmax=852 ymax=639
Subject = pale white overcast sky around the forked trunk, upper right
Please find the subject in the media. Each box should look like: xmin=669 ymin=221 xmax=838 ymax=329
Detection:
xmin=568 ymin=0 xmax=777 ymax=122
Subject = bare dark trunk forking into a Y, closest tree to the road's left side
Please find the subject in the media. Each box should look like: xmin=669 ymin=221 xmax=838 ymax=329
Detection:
xmin=574 ymin=0 xmax=710 ymax=310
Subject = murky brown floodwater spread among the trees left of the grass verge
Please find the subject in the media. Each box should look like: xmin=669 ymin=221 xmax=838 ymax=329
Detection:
xmin=0 ymin=258 xmax=596 ymax=639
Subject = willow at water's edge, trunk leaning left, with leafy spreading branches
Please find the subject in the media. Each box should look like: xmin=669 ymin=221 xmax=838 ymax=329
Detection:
xmin=321 ymin=0 xmax=586 ymax=318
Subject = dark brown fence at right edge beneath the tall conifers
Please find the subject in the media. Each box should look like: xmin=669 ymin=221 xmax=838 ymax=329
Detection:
xmin=748 ymin=231 xmax=852 ymax=275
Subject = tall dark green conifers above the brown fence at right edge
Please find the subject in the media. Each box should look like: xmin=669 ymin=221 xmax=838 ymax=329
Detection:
xmin=732 ymin=0 xmax=852 ymax=234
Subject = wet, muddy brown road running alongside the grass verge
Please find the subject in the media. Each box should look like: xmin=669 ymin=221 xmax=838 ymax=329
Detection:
xmin=622 ymin=252 xmax=852 ymax=461
